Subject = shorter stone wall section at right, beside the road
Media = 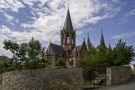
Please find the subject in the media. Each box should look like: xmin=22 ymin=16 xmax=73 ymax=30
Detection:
xmin=106 ymin=66 xmax=132 ymax=85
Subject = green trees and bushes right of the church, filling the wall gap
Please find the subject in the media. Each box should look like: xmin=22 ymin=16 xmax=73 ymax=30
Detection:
xmin=79 ymin=40 xmax=135 ymax=84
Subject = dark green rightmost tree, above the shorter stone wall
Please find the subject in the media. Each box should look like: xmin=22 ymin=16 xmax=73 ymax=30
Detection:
xmin=114 ymin=39 xmax=135 ymax=66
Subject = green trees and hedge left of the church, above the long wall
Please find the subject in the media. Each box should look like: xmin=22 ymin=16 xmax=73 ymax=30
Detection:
xmin=0 ymin=38 xmax=48 ymax=73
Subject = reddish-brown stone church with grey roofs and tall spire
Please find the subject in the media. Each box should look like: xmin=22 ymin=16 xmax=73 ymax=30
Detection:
xmin=45 ymin=9 xmax=104 ymax=66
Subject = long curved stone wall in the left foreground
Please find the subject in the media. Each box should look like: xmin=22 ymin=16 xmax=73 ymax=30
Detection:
xmin=1 ymin=68 xmax=82 ymax=90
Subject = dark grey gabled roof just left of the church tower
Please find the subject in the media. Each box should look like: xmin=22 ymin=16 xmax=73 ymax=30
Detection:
xmin=46 ymin=43 xmax=65 ymax=56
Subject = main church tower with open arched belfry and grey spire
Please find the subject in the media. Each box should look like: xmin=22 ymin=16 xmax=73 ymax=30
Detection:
xmin=61 ymin=9 xmax=76 ymax=51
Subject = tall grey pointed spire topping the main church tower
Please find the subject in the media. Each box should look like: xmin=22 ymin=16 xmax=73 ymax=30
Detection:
xmin=63 ymin=8 xmax=73 ymax=30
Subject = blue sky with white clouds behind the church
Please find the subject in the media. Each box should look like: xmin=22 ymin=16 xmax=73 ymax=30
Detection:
xmin=0 ymin=0 xmax=135 ymax=61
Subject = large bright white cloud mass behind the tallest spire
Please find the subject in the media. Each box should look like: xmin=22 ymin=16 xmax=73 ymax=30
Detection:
xmin=16 ymin=0 xmax=120 ymax=44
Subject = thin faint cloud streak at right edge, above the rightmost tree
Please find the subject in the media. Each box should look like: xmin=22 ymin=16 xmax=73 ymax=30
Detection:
xmin=111 ymin=32 xmax=135 ymax=39
